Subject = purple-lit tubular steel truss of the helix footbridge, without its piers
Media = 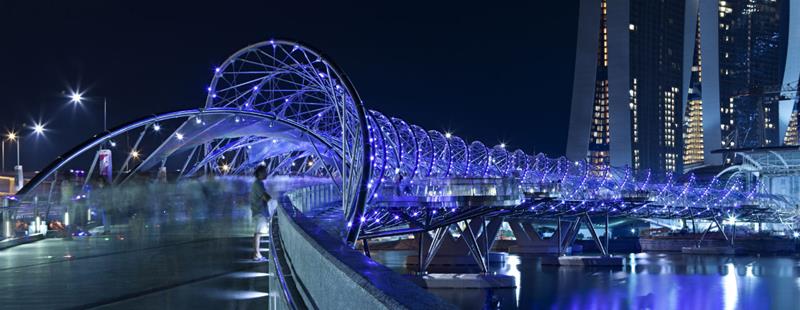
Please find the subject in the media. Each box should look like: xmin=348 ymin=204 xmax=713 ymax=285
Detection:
xmin=9 ymin=40 xmax=796 ymax=244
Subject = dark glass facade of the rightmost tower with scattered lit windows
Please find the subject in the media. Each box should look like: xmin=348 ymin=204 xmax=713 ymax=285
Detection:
xmin=718 ymin=0 xmax=789 ymax=154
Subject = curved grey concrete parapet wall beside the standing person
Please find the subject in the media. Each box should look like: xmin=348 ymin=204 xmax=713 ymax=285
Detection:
xmin=270 ymin=188 xmax=454 ymax=309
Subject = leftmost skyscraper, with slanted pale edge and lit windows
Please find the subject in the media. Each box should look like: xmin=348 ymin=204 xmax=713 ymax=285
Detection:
xmin=567 ymin=0 xmax=684 ymax=172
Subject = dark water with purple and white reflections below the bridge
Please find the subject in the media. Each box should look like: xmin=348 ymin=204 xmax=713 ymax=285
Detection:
xmin=378 ymin=251 xmax=800 ymax=309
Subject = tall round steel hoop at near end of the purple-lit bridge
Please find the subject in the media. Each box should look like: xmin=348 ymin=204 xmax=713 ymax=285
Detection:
xmin=205 ymin=39 xmax=372 ymax=242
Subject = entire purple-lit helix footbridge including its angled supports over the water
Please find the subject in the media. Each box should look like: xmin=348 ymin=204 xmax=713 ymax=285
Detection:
xmin=3 ymin=40 xmax=797 ymax=308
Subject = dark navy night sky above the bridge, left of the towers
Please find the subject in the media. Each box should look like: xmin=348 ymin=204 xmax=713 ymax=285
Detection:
xmin=0 ymin=0 xmax=577 ymax=170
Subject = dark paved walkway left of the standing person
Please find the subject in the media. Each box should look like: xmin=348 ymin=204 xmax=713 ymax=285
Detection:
xmin=0 ymin=231 xmax=269 ymax=309
